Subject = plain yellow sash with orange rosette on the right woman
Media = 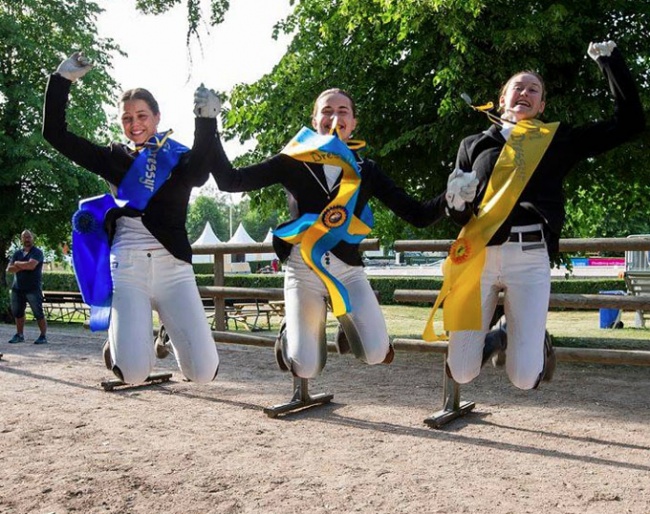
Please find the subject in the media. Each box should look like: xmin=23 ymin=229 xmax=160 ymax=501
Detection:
xmin=422 ymin=120 xmax=559 ymax=341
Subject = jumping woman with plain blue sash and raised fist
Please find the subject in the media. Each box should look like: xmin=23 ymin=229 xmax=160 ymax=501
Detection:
xmin=43 ymin=52 xmax=219 ymax=383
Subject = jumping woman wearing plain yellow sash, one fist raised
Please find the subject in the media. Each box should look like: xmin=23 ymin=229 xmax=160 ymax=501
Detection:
xmin=425 ymin=41 xmax=645 ymax=389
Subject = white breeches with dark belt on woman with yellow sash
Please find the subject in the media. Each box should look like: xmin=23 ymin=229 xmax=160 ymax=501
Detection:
xmin=447 ymin=228 xmax=551 ymax=389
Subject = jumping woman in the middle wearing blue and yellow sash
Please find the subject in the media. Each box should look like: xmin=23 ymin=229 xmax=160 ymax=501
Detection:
xmin=206 ymin=89 xmax=476 ymax=378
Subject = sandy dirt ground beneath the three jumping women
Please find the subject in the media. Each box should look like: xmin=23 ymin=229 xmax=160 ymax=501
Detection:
xmin=0 ymin=322 xmax=650 ymax=514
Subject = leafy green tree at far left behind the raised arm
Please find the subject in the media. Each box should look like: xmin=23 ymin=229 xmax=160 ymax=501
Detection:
xmin=0 ymin=0 xmax=117 ymax=318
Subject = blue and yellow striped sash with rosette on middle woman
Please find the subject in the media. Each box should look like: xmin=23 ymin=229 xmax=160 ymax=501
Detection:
xmin=274 ymin=127 xmax=374 ymax=317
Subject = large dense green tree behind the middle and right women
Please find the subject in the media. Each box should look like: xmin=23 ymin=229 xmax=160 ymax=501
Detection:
xmin=219 ymin=0 xmax=650 ymax=243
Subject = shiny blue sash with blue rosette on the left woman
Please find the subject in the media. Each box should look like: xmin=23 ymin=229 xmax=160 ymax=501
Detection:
xmin=72 ymin=131 xmax=189 ymax=331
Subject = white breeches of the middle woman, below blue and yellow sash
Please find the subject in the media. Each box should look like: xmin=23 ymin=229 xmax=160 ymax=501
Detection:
xmin=284 ymin=246 xmax=389 ymax=378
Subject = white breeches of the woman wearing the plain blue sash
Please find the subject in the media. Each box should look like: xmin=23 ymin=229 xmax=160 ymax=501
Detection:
xmin=108 ymin=249 xmax=219 ymax=383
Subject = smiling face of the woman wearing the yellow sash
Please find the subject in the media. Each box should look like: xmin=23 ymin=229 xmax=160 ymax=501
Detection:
xmin=499 ymin=72 xmax=546 ymax=123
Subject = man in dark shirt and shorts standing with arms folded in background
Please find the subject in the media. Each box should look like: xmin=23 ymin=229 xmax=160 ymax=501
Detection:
xmin=7 ymin=230 xmax=47 ymax=344
